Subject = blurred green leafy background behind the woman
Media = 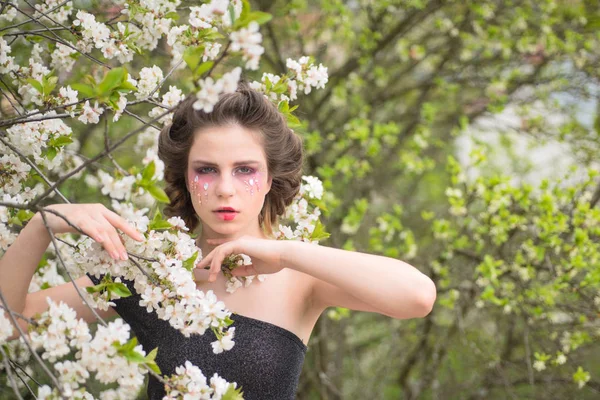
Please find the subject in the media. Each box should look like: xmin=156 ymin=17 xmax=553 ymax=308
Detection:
xmin=0 ymin=0 xmax=600 ymax=400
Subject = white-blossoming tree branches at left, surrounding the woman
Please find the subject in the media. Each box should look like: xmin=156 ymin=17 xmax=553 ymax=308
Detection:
xmin=0 ymin=0 xmax=327 ymax=399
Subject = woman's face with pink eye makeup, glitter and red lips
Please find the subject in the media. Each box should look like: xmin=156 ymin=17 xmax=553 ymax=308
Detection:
xmin=187 ymin=124 xmax=271 ymax=237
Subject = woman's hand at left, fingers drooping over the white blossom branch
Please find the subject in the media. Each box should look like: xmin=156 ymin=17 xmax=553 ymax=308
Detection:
xmin=32 ymin=203 xmax=144 ymax=260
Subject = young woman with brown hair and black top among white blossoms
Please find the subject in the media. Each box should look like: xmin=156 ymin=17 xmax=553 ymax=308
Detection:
xmin=0 ymin=84 xmax=436 ymax=400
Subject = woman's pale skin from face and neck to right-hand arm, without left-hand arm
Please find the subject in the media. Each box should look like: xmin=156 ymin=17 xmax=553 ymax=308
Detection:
xmin=188 ymin=125 xmax=436 ymax=343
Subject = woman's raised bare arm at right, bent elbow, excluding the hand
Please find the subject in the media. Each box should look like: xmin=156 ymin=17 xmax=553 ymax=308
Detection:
xmin=281 ymin=240 xmax=436 ymax=319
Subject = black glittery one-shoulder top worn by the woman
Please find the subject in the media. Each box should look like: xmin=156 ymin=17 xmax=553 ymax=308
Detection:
xmin=87 ymin=274 xmax=307 ymax=400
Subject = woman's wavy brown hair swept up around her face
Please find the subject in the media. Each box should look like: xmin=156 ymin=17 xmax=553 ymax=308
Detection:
xmin=158 ymin=82 xmax=304 ymax=236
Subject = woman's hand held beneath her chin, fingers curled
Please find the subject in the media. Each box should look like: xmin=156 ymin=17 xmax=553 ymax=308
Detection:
xmin=196 ymin=236 xmax=285 ymax=282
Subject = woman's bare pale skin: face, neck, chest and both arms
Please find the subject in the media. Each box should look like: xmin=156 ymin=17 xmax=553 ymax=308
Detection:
xmin=0 ymin=125 xmax=436 ymax=343
